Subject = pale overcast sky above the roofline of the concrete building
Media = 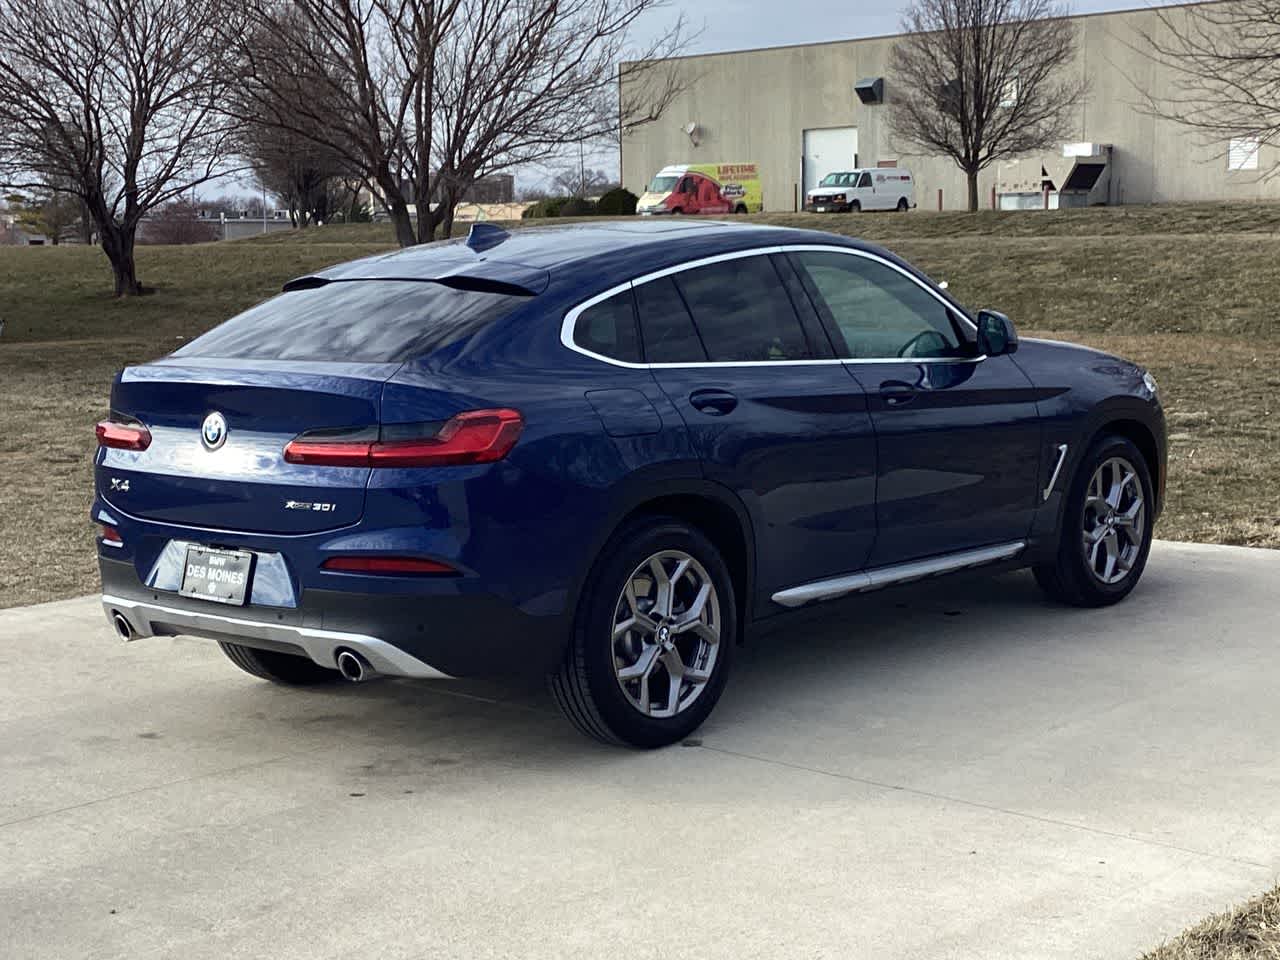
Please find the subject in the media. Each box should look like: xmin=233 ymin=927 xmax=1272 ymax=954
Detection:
xmin=645 ymin=0 xmax=1172 ymax=54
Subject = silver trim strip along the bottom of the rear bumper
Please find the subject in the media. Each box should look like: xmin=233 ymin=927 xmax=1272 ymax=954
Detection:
xmin=102 ymin=594 xmax=451 ymax=680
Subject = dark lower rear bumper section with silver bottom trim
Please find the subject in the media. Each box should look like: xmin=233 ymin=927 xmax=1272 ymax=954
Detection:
xmin=99 ymin=557 xmax=568 ymax=678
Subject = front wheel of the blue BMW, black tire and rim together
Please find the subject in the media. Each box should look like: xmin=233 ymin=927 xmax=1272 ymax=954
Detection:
xmin=1033 ymin=434 xmax=1155 ymax=607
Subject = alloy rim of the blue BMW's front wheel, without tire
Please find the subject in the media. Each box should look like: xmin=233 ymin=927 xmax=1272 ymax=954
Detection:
xmin=1083 ymin=457 xmax=1147 ymax=585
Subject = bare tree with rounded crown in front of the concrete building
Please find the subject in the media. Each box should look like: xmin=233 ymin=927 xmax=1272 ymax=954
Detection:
xmin=890 ymin=0 xmax=1087 ymax=210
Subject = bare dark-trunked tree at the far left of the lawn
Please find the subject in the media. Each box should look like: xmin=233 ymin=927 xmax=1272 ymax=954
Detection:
xmin=0 ymin=0 xmax=236 ymax=297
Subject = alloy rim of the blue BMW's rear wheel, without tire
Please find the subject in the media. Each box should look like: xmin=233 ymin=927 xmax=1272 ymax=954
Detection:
xmin=613 ymin=550 xmax=721 ymax=717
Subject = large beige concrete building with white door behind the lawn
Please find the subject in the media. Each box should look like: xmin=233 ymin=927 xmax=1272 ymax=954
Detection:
xmin=622 ymin=0 xmax=1280 ymax=211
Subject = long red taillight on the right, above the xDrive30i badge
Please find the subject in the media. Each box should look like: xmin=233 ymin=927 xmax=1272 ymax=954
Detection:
xmin=284 ymin=408 xmax=525 ymax=467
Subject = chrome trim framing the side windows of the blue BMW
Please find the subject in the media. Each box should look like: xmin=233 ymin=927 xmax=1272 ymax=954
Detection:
xmin=561 ymin=243 xmax=987 ymax=370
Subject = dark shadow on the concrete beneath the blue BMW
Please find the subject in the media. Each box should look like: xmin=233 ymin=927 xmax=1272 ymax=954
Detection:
xmin=194 ymin=571 xmax=1182 ymax=768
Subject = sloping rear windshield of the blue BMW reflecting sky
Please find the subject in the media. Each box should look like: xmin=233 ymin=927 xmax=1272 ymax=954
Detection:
xmin=174 ymin=280 xmax=529 ymax=364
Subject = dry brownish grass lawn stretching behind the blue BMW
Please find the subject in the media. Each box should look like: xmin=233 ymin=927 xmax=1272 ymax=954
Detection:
xmin=0 ymin=205 xmax=1280 ymax=607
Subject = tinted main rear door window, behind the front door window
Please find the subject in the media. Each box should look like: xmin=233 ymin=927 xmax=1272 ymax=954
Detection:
xmin=675 ymin=256 xmax=813 ymax=362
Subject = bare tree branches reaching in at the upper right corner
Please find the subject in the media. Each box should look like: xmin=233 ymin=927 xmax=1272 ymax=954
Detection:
xmin=1135 ymin=0 xmax=1280 ymax=163
